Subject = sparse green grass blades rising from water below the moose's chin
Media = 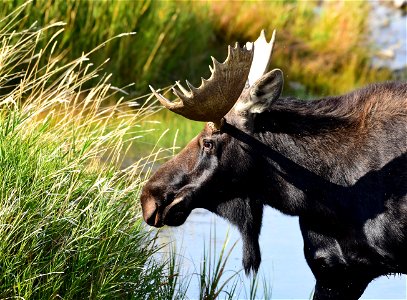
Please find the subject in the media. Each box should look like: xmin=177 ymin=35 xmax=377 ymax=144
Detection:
xmin=159 ymin=227 xmax=271 ymax=300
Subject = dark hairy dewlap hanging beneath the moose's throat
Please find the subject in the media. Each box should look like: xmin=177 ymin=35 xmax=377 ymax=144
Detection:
xmin=213 ymin=198 xmax=263 ymax=274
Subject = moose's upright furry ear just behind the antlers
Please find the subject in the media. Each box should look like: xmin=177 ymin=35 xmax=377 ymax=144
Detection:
xmin=248 ymin=69 xmax=284 ymax=113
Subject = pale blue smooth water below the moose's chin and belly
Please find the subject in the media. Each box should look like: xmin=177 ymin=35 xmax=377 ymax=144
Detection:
xmin=160 ymin=207 xmax=407 ymax=300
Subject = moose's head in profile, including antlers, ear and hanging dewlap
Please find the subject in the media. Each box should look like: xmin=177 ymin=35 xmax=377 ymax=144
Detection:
xmin=141 ymin=31 xmax=283 ymax=273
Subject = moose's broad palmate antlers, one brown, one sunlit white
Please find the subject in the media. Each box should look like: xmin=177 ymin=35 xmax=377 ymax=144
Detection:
xmin=150 ymin=30 xmax=274 ymax=129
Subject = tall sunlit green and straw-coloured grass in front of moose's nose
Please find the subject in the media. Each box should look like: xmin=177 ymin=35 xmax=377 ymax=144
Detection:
xmin=0 ymin=7 xmax=180 ymax=299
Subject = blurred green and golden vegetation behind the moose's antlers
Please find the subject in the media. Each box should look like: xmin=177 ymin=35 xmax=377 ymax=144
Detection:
xmin=0 ymin=0 xmax=398 ymax=96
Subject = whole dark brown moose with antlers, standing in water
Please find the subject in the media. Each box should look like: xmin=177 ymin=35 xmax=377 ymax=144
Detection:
xmin=140 ymin=31 xmax=407 ymax=300
